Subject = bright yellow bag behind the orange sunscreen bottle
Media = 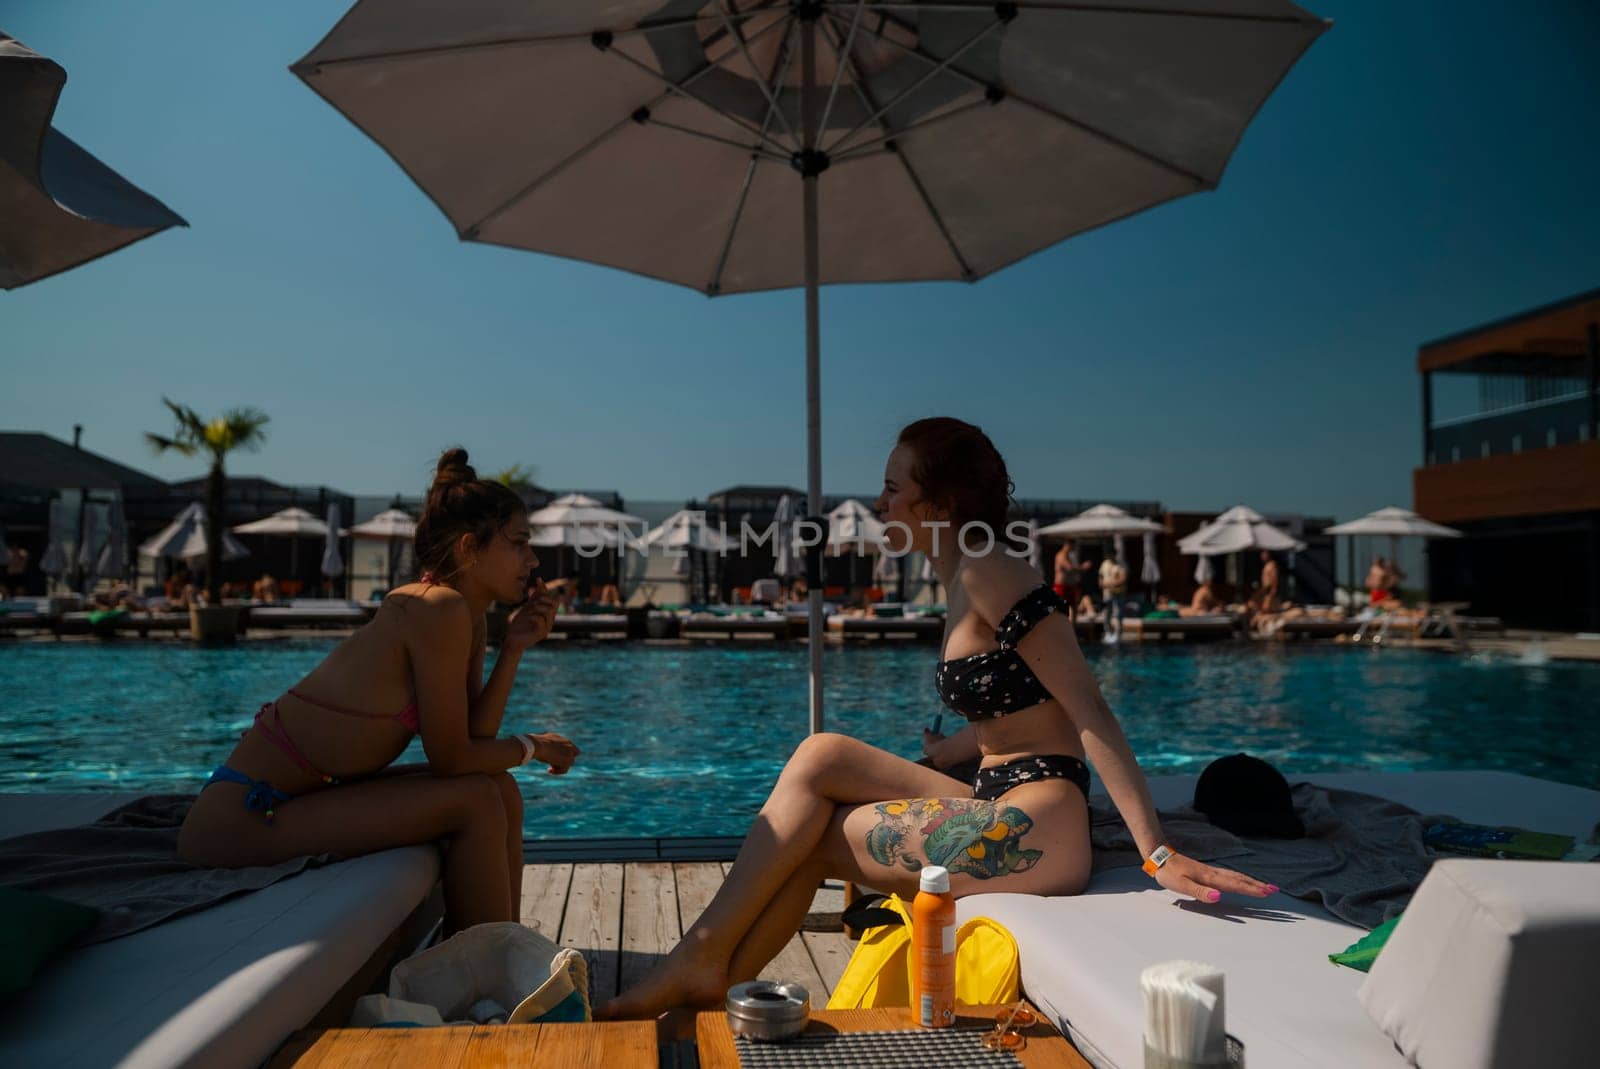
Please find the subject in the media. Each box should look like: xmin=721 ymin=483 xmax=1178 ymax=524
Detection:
xmin=827 ymin=895 xmax=1021 ymax=1010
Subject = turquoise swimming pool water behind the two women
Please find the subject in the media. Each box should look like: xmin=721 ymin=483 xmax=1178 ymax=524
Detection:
xmin=0 ymin=642 xmax=1600 ymax=837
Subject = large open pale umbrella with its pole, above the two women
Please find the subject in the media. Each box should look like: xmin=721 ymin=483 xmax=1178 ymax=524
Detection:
xmin=293 ymin=0 xmax=1326 ymax=731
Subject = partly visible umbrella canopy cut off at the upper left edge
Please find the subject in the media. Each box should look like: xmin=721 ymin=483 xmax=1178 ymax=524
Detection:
xmin=0 ymin=34 xmax=189 ymax=290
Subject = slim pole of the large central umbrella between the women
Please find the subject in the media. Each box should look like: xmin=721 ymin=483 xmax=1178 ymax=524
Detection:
xmin=800 ymin=14 xmax=822 ymax=735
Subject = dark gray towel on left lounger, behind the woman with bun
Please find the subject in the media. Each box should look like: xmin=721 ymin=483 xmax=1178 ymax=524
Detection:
xmin=0 ymin=794 xmax=338 ymax=946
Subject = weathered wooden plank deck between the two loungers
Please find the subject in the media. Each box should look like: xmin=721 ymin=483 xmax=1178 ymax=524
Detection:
xmin=522 ymin=861 xmax=856 ymax=1007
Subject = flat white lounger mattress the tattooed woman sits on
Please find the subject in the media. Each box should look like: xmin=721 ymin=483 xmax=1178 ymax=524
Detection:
xmin=957 ymin=773 xmax=1600 ymax=1069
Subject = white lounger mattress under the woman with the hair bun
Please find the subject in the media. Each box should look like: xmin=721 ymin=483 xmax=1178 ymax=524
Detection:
xmin=0 ymin=794 xmax=440 ymax=1069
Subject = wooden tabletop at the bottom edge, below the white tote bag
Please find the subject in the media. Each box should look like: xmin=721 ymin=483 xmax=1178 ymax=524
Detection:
xmin=269 ymin=1021 xmax=659 ymax=1069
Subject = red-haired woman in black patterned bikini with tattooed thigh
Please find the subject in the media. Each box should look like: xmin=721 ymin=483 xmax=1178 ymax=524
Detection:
xmin=597 ymin=419 xmax=1277 ymax=1018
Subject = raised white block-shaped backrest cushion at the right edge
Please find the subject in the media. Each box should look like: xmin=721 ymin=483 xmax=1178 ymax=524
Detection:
xmin=1358 ymin=859 xmax=1600 ymax=1069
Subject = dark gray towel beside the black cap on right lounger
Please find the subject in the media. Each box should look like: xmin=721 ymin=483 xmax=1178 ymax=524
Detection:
xmin=1090 ymin=783 xmax=1456 ymax=928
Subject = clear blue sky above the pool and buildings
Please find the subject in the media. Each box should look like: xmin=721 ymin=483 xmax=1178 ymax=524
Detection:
xmin=0 ymin=0 xmax=1600 ymax=518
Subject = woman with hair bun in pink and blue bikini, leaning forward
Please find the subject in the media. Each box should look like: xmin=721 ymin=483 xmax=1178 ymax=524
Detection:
xmin=178 ymin=448 xmax=578 ymax=931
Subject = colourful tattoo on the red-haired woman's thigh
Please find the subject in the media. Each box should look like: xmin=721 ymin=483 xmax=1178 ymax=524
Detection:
xmin=867 ymin=799 xmax=1045 ymax=880
